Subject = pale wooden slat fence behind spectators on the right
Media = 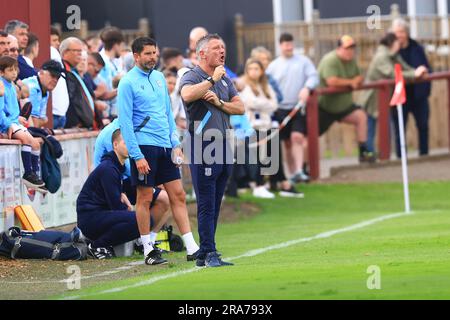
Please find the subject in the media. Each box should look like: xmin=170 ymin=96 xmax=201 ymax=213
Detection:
xmin=235 ymin=10 xmax=450 ymax=157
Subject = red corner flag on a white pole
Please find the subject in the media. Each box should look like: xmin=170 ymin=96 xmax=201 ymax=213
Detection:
xmin=391 ymin=64 xmax=411 ymax=213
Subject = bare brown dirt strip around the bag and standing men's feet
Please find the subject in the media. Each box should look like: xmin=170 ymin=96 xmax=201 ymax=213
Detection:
xmin=0 ymin=200 xmax=260 ymax=300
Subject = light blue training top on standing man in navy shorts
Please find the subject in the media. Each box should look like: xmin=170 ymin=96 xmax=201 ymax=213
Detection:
xmin=117 ymin=66 xmax=180 ymax=160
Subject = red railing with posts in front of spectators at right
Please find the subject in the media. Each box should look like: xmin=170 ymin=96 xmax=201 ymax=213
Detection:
xmin=307 ymin=71 xmax=450 ymax=180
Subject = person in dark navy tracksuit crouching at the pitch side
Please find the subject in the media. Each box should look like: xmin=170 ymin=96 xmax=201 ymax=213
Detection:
xmin=77 ymin=129 xmax=153 ymax=259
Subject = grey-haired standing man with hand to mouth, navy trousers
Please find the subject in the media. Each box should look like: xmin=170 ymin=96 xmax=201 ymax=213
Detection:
xmin=180 ymin=34 xmax=244 ymax=267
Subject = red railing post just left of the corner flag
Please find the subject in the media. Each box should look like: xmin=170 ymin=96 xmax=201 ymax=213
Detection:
xmin=378 ymin=85 xmax=391 ymax=160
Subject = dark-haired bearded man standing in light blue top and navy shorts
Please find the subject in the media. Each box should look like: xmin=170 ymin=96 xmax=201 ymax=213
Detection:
xmin=117 ymin=37 xmax=199 ymax=265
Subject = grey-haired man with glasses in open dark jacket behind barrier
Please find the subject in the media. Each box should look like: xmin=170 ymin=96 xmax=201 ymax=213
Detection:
xmin=60 ymin=37 xmax=96 ymax=128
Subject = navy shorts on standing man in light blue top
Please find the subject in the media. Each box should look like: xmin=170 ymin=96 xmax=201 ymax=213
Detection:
xmin=130 ymin=146 xmax=181 ymax=187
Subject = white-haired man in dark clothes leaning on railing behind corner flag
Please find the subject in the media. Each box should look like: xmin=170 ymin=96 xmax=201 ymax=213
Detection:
xmin=391 ymin=19 xmax=431 ymax=158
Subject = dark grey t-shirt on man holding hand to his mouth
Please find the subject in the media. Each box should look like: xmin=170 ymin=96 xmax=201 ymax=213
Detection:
xmin=180 ymin=66 xmax=238 ymax=137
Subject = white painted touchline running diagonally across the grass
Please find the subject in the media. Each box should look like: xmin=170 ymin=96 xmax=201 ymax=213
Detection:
xmin=62 ymin=210 xmax=441 ymax=300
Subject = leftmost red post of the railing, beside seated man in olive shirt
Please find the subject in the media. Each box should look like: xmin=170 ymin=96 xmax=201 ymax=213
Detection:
xmin=306 ymin=91 xmax=320 ymax=180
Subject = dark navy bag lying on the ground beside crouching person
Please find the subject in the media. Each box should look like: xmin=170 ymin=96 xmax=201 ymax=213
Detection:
xmin=0 ymin=227 xmax=87 ymax=261
